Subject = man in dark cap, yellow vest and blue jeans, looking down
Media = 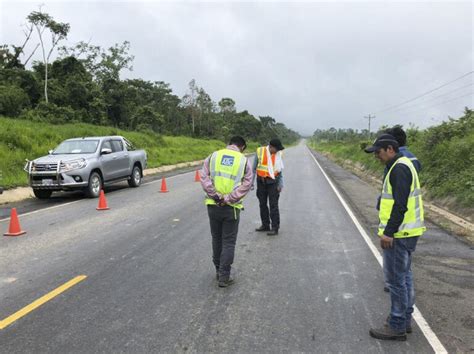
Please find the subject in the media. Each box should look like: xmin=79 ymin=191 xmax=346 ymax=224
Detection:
xmin=365 ymin=134 xmax=426 ymax=340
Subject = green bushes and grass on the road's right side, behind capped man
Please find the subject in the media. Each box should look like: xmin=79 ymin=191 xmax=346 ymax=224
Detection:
xmin=310 ymin=108 xmax=474 ymax=208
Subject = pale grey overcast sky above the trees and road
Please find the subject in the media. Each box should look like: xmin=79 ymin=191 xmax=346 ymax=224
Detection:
xmin=0 ymin=0 xmax=474 ymax=134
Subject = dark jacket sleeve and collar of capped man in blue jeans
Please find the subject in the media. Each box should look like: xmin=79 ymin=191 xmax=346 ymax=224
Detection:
xmin=384 ymin=153 xmax=413 ymax=237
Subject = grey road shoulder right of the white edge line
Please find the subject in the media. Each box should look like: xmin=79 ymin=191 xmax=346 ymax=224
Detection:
xmin=312 ymin=147 xmax=474 ymax=352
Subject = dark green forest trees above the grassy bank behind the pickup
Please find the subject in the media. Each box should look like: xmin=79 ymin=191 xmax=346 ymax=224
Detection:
xmin=0 ymin=11 xmax=299 ymax=148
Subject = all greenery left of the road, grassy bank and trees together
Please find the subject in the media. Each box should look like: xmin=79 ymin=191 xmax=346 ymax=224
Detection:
xmin=0 ymin=10 xmax=299 ymax=188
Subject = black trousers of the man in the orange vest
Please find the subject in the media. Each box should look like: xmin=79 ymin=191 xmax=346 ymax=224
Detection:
xmin=257 ymin=177 xmax=280 ymax=229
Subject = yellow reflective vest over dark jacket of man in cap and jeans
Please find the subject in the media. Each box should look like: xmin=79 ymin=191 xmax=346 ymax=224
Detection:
xmin=378 ymin=157 xmax=426 ymax=238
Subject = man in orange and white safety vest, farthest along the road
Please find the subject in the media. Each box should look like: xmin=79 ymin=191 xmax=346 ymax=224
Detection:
xmin=253 ymin=139 xmax=284 ymax=236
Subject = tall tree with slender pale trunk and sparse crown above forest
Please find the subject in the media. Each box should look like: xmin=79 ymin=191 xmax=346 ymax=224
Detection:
xmin=27 ymin=9 xmax=70 ymax=103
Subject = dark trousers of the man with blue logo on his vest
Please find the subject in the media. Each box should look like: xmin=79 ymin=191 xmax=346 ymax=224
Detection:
xmin=207 ymin=205 xmax=240 ymax=280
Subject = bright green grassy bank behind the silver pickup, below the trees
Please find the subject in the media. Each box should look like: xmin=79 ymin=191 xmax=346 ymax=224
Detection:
xmin=0 ymin=117 xmax=258 ymax=188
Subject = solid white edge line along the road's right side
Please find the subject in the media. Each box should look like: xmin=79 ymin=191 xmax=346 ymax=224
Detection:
xmin=308 ymin=148 xmax=448 ymax=354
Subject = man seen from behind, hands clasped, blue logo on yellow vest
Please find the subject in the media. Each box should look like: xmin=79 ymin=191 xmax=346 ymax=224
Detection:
xmin=201 ymin=136 xmax=253 ymax=288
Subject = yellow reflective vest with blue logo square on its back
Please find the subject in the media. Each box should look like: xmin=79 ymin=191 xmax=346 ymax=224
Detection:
xmin=205 ymin=149 xmax=247 ymax=209
